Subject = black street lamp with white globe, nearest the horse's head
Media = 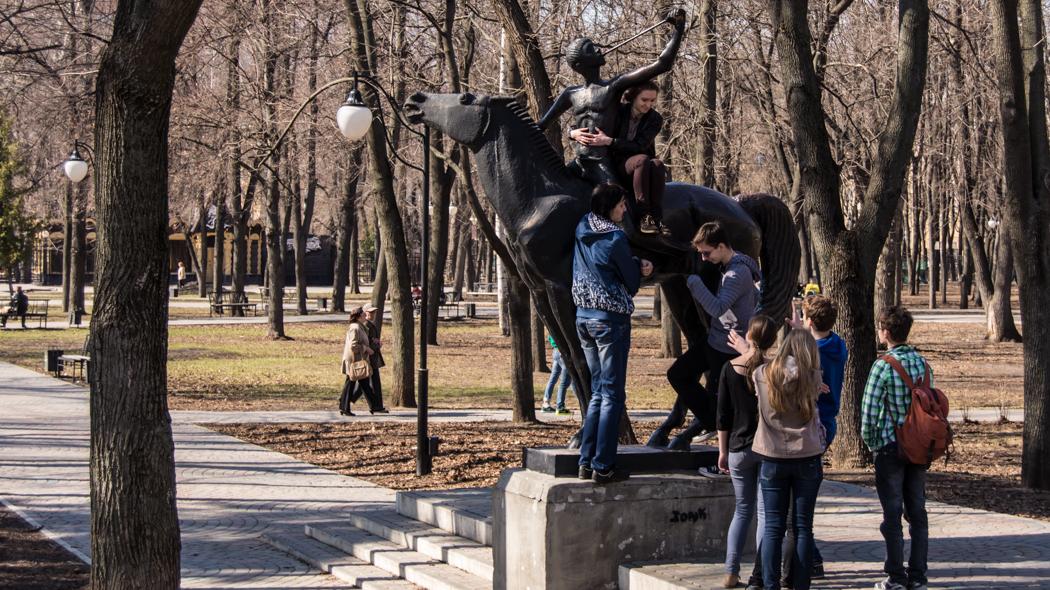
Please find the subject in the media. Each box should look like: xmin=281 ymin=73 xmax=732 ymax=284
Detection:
xmin=336 ymin=73 xmax=436 ymax=476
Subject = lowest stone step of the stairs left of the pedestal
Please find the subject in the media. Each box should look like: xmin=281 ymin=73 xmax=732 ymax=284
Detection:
xmin=260 ymin=529 xmax=419 ymax=590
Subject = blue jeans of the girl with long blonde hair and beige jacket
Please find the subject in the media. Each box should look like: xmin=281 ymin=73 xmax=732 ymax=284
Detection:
xmin=758 ymin=456 xmax=824 ymax=590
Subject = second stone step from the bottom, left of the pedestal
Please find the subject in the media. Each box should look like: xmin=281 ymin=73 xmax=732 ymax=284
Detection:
xmin=306 ymin=522 xmax=492 ymax=590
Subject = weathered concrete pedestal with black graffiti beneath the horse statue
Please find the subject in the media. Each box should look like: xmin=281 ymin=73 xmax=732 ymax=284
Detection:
xmin=492 ymin=469 xmax=739 ymax=590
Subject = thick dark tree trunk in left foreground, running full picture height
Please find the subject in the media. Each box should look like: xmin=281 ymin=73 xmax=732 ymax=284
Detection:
xmin=89 ymin=0 xmax=201 ymax=590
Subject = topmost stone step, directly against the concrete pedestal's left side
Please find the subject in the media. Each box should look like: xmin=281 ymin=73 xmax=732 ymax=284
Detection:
xmin=397 ymin=488 xmax=492 ymax=545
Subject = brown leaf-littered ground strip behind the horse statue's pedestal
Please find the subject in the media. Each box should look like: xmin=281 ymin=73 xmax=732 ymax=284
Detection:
xmin=209 ymin=422 xmax=1050 ymax=521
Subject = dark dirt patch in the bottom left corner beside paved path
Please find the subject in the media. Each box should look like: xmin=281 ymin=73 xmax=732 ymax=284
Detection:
xmin=0 ymin=505 xmax=91 ymax=590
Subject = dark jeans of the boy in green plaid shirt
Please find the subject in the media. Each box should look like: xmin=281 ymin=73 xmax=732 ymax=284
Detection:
xmin=875 ymin=442 xmax=929 ymax=586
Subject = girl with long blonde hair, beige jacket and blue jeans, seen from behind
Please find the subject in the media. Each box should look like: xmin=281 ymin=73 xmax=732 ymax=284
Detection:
xmin=752 ymin=330 xmax=825 ymax=590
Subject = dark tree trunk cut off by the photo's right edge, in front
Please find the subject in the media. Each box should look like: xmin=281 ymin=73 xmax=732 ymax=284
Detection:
xmin=990 ymin=0 xmax=1050 ymax=489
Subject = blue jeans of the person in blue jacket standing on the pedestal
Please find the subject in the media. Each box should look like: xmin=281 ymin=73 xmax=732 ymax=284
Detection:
xmin=576 ymin=318 xmax=631 ymax=471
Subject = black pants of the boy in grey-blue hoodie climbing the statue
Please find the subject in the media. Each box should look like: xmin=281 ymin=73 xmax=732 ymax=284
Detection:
xmin=662 ymin=342 xmax=736 ymax=430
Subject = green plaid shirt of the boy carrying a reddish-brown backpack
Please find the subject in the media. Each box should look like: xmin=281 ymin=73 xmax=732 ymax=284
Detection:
xmin=860 ymin=344 xmax=933 ymax=451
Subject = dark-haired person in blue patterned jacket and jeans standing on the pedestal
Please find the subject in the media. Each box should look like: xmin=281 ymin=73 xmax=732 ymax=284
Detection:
xmin=572 ymin=184 xmax=653 ymax=484
